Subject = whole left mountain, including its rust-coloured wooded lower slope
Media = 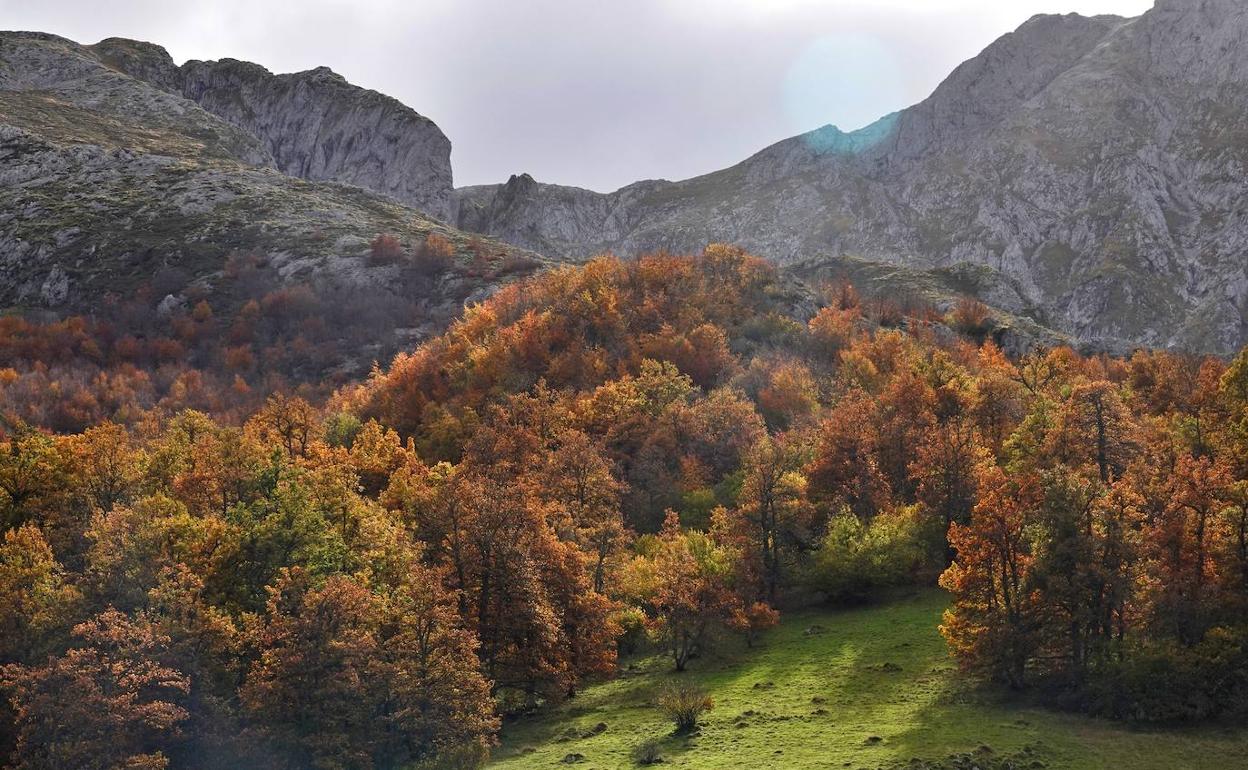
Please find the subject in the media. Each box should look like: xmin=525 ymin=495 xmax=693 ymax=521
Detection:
xmin=0 ymin=32 xmax=545 ymax=419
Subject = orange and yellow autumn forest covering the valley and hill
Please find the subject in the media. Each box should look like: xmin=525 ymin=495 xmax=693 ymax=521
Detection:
xmin=0 ymin=249 xmax=1248 ymax=770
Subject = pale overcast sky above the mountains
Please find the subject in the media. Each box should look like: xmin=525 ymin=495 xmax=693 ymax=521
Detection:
xmin=0 ymin=0 xmax=1152 ymax=191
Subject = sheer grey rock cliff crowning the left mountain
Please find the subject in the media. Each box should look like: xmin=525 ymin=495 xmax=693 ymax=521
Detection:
xmin=89 ymin=37 xmax=452 ymax=218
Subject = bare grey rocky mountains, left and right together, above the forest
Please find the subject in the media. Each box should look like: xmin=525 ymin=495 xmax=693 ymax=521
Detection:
xmin=0 ymin=0 xmax=1248 ymax=353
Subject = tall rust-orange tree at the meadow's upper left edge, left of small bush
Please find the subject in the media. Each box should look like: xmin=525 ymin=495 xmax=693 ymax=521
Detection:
xmin=384 ymin=414 xmax=618 ymax=709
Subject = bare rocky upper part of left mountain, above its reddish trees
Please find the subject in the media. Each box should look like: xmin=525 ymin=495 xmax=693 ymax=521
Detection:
xmin=0 ymin=32 xmax=531 ymax=341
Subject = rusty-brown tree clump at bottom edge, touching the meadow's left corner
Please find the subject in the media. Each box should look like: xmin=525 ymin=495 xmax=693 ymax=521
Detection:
xmin=241 ymin=565 xmax=497 ymax=770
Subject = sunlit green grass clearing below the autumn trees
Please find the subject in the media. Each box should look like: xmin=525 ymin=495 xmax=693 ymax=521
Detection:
xmin=490 ymin=590 xmax=1248 ymax=770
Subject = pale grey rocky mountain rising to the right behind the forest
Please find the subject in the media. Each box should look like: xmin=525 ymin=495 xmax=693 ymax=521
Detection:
xmin=454 ymin=0 xmax=1248 ymax=352
